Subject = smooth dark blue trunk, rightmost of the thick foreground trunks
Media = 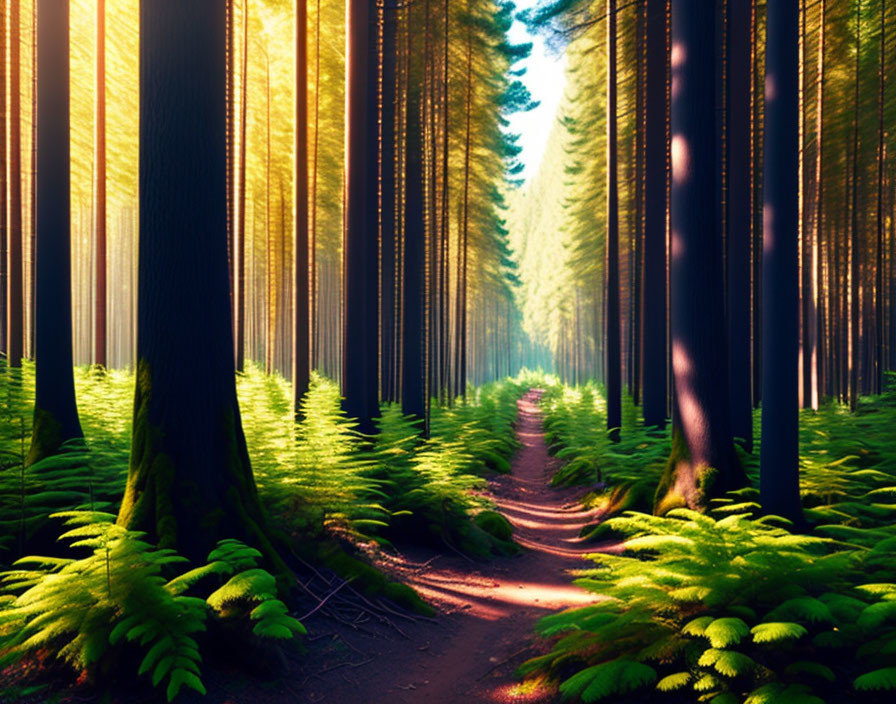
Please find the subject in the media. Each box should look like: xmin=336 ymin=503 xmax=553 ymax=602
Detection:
xmin=759 ymin=0 xmax=802 ymax=521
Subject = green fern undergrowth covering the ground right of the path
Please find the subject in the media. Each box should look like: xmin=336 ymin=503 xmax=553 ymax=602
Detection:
xmin=523 ymin=379 xmax=896 ymax=704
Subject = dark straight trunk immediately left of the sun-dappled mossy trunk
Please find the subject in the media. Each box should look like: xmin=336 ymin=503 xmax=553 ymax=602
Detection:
xmin=641 ymin=0 xmax=669 ymax=428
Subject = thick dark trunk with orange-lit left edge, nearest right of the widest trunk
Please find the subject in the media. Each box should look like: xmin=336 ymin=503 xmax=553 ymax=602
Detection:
xmin=342 ymin=0 xmax=379 ymax=434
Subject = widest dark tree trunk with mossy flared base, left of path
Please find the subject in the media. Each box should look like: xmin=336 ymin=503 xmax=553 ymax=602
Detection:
xmin=118 ymin=0 xmax=276 ymax=561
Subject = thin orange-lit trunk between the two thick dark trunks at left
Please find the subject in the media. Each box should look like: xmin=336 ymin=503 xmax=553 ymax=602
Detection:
xmin=93 ymin=0 xmax=107 ymax=367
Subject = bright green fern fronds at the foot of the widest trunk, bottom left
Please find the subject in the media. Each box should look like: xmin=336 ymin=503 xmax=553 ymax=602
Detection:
xmin=0 ymin=511 xmax=305 ymax=701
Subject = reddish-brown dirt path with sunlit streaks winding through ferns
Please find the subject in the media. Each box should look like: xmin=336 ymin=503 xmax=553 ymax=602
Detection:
xmin=292 ymin=389 xmax=595 ymax=704
